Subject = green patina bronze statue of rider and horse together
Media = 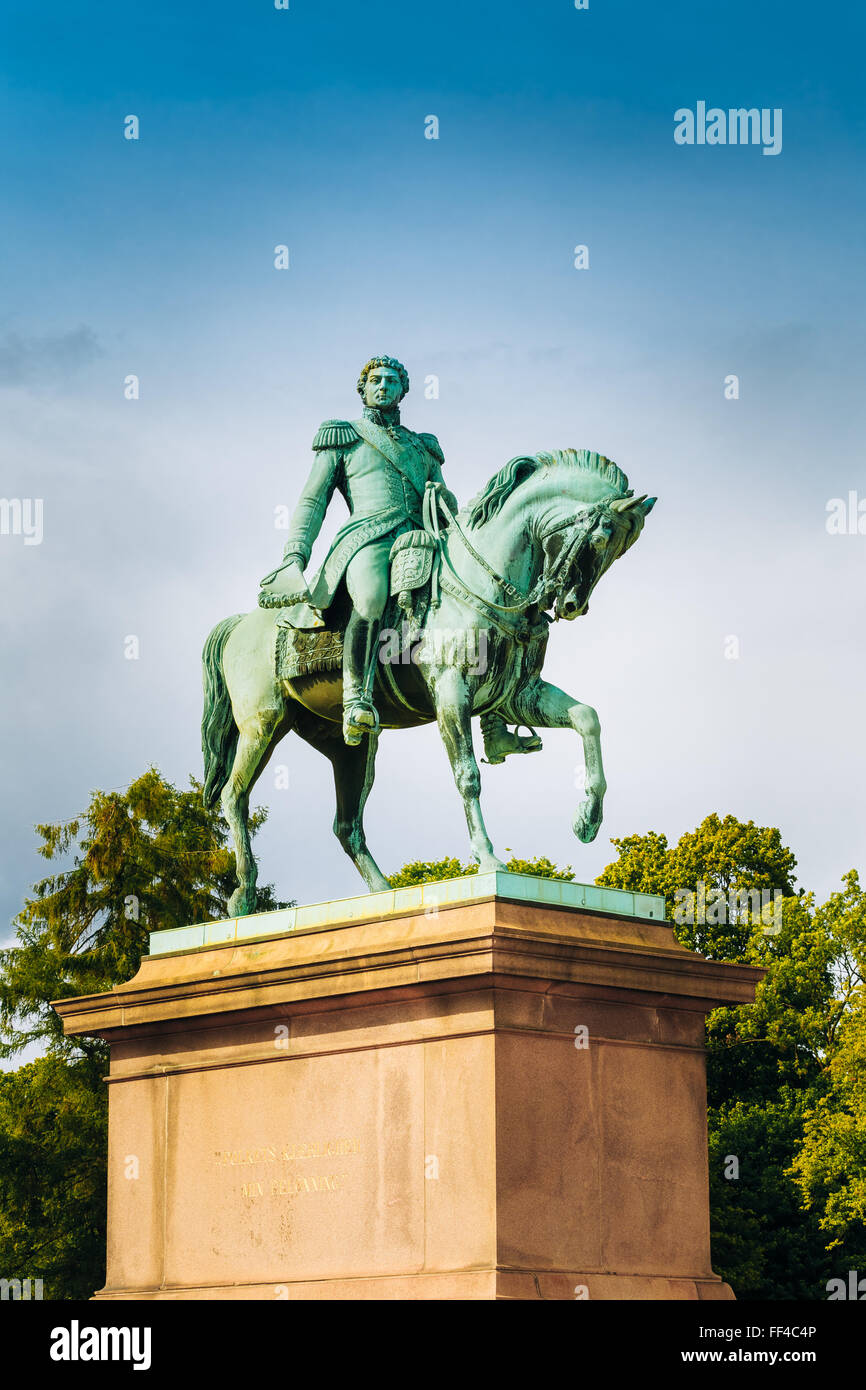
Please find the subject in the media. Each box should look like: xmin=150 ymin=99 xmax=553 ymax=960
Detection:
xmin=202 ymin=357 xmax=655 ymax=916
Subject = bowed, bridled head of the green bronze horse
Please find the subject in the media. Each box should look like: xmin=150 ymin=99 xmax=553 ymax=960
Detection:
xmin=539 ymin=496 xmax=656 ymax=621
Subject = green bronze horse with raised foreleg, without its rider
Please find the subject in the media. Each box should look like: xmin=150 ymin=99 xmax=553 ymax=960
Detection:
xmin=202 ymin=449 xmax=656 ymax=916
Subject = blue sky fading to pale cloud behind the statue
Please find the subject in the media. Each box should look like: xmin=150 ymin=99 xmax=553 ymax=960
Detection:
xmin=0 ymin=0 xmax=866 ymax=989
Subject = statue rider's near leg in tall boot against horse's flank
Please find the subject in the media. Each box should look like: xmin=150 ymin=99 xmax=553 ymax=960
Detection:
xmin=343 ymin=539 xmax=392 ymax=744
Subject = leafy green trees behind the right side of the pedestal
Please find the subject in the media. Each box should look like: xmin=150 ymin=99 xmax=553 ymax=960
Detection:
xmin=596 ymin=815 xmax=863 ymax=1298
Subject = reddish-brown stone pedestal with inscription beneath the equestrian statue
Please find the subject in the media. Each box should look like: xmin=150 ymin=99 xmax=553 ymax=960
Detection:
xmin=57 ymin=874 xmax=760 ymax=1300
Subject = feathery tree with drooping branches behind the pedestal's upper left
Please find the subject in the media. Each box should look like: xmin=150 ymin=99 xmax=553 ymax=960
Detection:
xmin=0 ymin=767 xmax=285 ymax=1056
